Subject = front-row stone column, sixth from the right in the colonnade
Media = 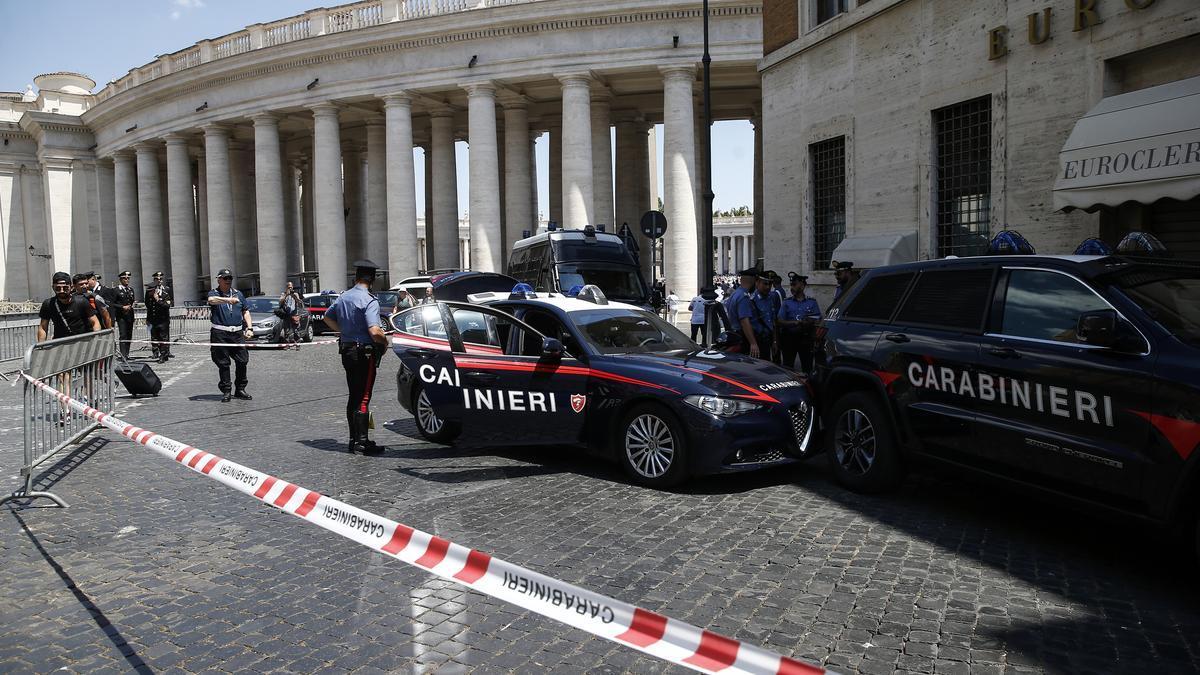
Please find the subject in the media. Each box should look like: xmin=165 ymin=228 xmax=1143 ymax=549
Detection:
xmin=251 ymin=113 xmax=288 ymax=295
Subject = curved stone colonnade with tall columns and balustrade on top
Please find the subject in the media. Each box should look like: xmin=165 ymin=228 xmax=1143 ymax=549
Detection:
xmin=0 ymin=0 xmax=762 ymax=299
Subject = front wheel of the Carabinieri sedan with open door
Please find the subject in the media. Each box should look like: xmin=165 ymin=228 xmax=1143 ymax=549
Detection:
xmin=617 ymin=405 xmax=688 ymax=488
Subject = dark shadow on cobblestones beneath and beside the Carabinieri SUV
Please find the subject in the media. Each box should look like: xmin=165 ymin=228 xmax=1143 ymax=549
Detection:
xmin=799 ymin=470 xmax=1200 ymax=673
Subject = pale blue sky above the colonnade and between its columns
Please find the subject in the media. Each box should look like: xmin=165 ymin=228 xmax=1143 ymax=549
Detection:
xmin=0 ymin=0 xmax=754 ymax=214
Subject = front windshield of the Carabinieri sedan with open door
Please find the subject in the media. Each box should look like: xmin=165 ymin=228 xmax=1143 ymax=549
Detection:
xmin=568 ymin=309 xmax=697 ymax=354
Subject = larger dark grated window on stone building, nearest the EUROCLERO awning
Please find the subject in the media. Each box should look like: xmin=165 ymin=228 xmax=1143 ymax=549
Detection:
xmin=934 ymin=96 xmax=991 ymax=257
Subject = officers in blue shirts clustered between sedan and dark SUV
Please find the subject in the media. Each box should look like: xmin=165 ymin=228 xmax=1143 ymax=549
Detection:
xmin=725 ymin=262 xmax=856 ymax=372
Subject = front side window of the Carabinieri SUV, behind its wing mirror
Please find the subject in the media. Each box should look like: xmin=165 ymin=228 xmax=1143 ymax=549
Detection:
xmin=1000 ymin=269 xmax=1111 ymax=344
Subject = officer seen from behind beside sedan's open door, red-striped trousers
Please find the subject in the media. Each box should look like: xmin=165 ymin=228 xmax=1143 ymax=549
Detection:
xmin=325 ymin=261 xmax=388 ymax=455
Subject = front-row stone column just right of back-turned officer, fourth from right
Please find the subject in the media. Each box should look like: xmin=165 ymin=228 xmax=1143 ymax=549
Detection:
xmin=388 ymin=94 xmax=428 ymax=277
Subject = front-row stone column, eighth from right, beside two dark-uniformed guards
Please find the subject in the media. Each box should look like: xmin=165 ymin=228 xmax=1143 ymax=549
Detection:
xmin=166 ymin=133 xmax=200 ymax=306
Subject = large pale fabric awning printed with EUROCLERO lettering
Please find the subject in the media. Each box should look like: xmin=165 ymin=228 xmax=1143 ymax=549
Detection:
xmin=1054 ymin=77 xmax=1200 ymax=210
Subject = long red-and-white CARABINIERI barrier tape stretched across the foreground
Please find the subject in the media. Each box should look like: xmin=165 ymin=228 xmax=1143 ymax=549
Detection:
xmin=20 ymin=372 xmax=824 ymax=675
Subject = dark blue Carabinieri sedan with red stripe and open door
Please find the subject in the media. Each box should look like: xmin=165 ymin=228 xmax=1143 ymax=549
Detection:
xmin=391 ymin=283 xmax=815 ymax=488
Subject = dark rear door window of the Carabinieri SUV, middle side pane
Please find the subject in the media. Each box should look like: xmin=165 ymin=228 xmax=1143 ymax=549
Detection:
xmin=896 ymin=267 xmax=995 ymax=331
